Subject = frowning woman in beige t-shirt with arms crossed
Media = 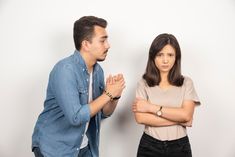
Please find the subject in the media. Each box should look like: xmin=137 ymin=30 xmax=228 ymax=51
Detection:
xmin=132 ymin=34 xmax=200 ymax=157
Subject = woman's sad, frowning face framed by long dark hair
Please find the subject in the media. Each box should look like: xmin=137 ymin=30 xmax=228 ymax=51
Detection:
xmin=154 ymin=44 xmax=176 ymax=74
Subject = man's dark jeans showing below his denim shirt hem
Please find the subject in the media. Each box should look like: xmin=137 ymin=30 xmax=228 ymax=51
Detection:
xmin=33 ymin=145 xmax=92 ymax=157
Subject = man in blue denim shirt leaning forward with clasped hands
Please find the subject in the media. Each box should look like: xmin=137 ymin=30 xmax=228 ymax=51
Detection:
xmin=32 ymin=16 xmax=125 ymax=157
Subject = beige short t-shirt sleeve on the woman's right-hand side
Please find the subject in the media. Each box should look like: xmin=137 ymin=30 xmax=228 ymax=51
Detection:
xmin=184 ymin=77 xmax=201 ymax=105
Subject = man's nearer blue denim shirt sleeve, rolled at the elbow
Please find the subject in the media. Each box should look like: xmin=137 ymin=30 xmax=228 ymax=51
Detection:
xmin=53 ymin=64 xmax=90 ymax=125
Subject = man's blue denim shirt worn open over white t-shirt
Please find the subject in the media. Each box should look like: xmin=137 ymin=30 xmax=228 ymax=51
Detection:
xmin=32 ymin=50 xmax=106 ymax=157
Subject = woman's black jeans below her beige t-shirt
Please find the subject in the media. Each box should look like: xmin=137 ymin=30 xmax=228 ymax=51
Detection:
xmin=137 ymin=133 xmax=192 ymax=157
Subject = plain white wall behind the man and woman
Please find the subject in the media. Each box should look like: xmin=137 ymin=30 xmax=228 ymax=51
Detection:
xmin=0 ymin=0 xmax=235 ymax=157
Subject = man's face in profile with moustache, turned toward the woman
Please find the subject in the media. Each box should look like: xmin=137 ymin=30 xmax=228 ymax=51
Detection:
xmin=89 ymin=26 xmax=110 ymax=61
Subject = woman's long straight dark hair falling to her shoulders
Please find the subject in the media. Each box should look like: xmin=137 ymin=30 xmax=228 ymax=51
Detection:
xmin=143 ymin=33 xmax=184 ymax=87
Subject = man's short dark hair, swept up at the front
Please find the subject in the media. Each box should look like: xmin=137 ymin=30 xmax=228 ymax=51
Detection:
xmin=73 ymin=16 xmax=107 ymax=50
